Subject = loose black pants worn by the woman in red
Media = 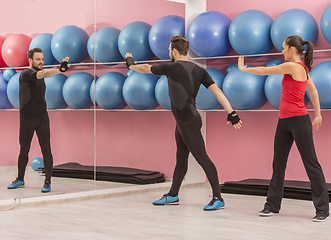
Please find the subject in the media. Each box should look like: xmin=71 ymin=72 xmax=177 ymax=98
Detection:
xmin=265 ymin=114 xmax=329 ymax=213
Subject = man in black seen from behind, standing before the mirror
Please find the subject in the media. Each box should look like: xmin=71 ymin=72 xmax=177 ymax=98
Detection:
xmin=126 ymin=36 xmax=242 ymax=211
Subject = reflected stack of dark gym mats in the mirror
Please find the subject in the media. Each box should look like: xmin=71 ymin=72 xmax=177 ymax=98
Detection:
xmin=45 ymin=162 xmax=165 ymax=184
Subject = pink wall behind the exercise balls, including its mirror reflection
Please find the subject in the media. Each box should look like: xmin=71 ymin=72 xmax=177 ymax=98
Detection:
xmin=0 ymin=0 xmax=331 ymax=186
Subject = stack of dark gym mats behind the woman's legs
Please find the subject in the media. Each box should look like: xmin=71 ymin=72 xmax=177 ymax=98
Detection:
xmin=220 ymin=179 xmax=331 ymax=202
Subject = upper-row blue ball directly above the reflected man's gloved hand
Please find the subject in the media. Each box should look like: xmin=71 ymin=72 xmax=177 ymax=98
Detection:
xmin=51 ymin=25 xmax=89 ymax=63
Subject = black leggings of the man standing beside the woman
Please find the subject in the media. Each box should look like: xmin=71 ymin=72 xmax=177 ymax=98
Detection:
xmin=169 ymin=115 xmax=221 ymax=198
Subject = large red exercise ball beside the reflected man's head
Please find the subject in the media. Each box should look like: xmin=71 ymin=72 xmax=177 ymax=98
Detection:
xmin=1 ymin=34 xmax=32 ymax=67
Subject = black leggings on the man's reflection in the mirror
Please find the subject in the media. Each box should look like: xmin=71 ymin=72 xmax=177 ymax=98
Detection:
xmin=18 ymin=114 xmax=53 ymax=181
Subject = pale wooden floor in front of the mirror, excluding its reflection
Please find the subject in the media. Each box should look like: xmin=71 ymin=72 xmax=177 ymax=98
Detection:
xmin=0 ymin=181 xmax=331 ymax=240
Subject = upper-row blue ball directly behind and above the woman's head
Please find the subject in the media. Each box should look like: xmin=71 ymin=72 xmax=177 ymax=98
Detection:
xmin=271 ymin=9 xmax=318 ymax=52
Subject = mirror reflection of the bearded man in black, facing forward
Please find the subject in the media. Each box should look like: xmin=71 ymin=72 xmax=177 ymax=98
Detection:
xmin=8 ymin=48 xmax=69 ymax=192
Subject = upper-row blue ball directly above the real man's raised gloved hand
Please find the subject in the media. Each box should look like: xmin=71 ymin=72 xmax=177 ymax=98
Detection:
xmin=118 ymin=22 xmax=154 ymax=61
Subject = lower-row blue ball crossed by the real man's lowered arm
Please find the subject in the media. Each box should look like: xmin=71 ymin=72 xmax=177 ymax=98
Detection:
xmin=196 ymin=68 xmax=225 ymax=110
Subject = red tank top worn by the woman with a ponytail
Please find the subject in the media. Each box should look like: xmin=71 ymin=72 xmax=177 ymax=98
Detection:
xmin=279 ymin=62 xmax=309 ymax=118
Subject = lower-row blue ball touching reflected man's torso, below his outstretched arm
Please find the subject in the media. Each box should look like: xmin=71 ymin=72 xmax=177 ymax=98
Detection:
xmin=45 ymin=74 xmax=67 ymax=109
